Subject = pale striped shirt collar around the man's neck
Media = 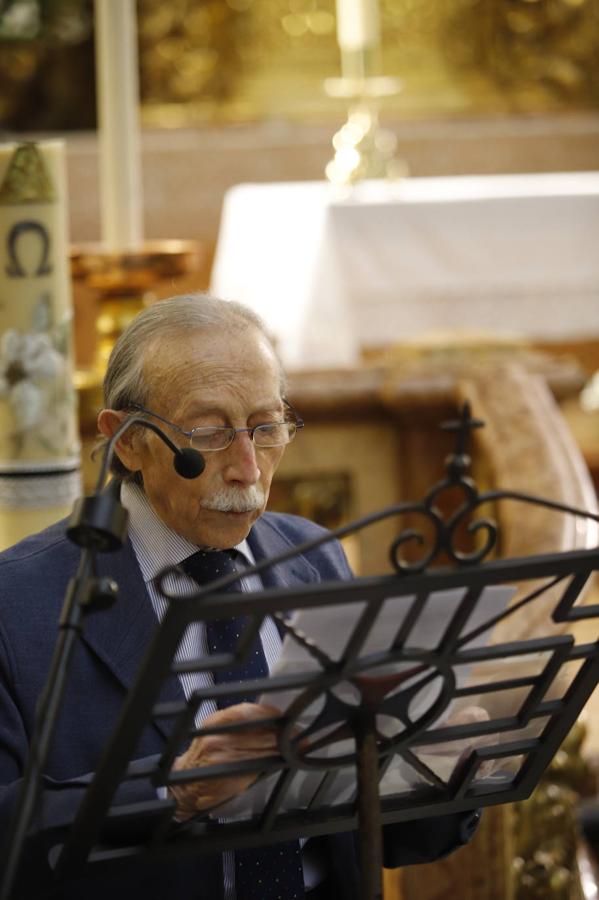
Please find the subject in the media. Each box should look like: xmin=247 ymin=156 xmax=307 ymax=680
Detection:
xmin=121 ymin=481 xmax=254 ymax=584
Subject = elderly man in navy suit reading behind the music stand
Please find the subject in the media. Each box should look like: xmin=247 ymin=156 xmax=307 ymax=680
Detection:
xmin=0 ymin=296 xmax=477 ymax=900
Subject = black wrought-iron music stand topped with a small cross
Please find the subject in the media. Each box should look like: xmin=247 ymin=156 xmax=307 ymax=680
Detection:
xmin=42 ymin=408 xmax=599 ymax=900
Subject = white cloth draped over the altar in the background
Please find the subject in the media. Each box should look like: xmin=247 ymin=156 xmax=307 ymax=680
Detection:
xmin=211 ymin=172 xmax=599 ymax=369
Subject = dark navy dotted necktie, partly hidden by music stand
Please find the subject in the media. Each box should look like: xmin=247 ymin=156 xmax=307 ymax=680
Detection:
xmin=182 ymin=550 xmax=304 ymax=900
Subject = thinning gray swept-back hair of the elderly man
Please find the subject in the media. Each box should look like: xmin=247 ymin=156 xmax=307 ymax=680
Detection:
xmin=95 ymin=293 xmax=285 ymax=480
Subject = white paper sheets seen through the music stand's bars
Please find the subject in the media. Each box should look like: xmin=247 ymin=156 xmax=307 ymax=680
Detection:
xmin=215 ymin=586 xmax=515 ymax=819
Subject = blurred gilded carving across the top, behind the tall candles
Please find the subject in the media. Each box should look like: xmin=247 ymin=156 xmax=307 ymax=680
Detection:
xmin=0 ymin=0 xmax=599 ymax=128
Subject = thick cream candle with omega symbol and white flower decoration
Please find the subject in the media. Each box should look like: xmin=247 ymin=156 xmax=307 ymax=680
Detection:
xmin=0 ymin=141 xmax=81 ymax=547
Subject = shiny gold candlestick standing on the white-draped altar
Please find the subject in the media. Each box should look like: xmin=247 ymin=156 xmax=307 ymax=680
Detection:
xmin=324 ymin=44 xmax=408 ymax=185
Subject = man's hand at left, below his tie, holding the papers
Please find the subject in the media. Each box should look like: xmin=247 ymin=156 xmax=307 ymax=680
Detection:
xmin=169 ymin=703 xmax=281 ymax=821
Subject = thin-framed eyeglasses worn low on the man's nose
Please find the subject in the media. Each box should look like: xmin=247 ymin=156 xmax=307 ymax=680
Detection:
xmin=129 ymin=399 xmax=304 ymax=453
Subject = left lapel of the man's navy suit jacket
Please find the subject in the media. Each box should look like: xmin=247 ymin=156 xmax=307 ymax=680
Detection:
xmin=83 ymin=541 xmax=185 ymax=735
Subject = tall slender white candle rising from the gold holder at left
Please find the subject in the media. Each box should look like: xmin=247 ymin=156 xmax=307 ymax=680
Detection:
xmin=95 ymin=0 xmax=143 ymax=252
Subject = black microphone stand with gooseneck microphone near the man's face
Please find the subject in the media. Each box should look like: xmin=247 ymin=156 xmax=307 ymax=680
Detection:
xmin=0 ymin=416 xmax=204 ymax=900
